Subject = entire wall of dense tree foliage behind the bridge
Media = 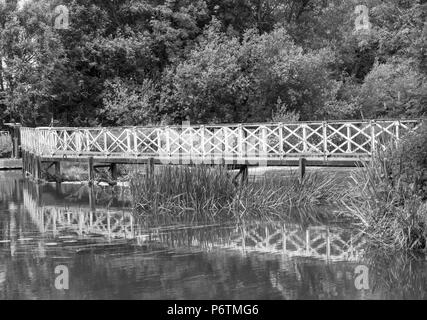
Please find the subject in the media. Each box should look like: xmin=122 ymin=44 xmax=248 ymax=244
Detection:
xmin=0 ymin=0 xmax=427 ymax=125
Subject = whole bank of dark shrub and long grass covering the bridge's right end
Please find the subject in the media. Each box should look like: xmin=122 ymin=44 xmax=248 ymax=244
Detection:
xmin=348 ymin=123 xmax=427 ymax=250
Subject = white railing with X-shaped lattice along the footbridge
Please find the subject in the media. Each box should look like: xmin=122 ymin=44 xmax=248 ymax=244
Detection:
xmin=21 ymin=120 xmax=421 ymax=164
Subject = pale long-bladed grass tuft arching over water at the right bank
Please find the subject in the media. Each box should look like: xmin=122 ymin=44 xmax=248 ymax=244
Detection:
xmin=345 ymin=146 xmax=427 ymax=251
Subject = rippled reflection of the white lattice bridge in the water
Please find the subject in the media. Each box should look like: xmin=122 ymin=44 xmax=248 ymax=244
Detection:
xmin=23 ymin=181 xmax=364 ymax=261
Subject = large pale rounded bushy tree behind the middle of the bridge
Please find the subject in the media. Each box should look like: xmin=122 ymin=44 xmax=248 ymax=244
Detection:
xmin=160 ymin=21 xmax=352 ymax=123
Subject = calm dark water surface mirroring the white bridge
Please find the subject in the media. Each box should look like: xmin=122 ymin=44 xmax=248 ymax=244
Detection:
xmin=0 ymin=172 xmax=427 ymax=299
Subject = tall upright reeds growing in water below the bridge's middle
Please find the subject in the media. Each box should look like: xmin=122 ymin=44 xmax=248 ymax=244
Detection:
xmin=130 ymin=166 xmax=342 ymax=221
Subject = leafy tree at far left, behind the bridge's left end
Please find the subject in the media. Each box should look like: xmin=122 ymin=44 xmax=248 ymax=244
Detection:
xmin=0 ymin=2 xmax=66 ymax=124
